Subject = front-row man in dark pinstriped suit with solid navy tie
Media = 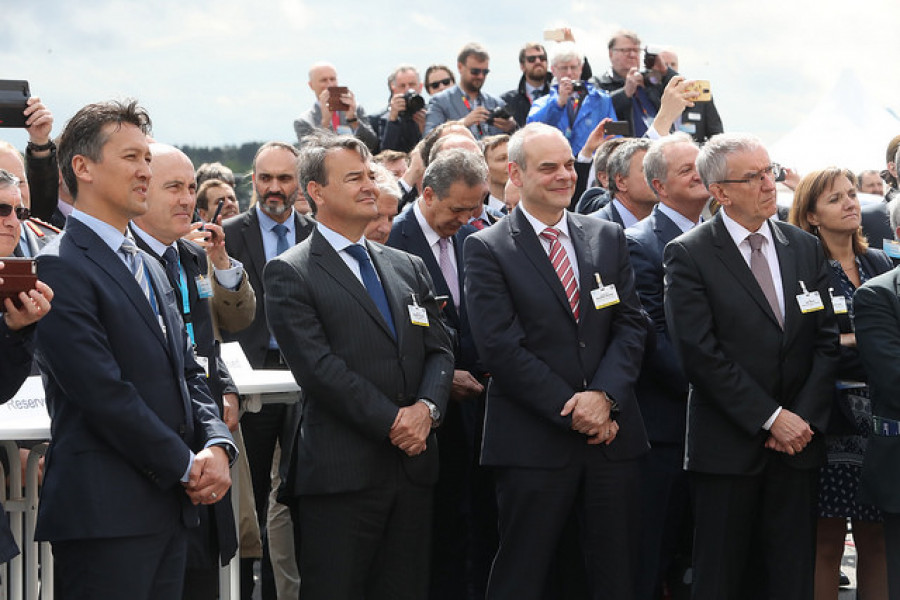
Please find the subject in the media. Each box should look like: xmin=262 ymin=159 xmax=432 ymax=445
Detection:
xmin=264 ymin=136 xmax=453 ymax=600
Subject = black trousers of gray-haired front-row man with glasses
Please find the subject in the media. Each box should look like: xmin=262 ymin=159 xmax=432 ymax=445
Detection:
xmin=690 ymin=456 xmax=819 ymax=600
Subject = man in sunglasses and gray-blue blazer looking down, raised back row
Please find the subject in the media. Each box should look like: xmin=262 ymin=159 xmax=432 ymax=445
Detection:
xmin=425 ymin=43 xmax=516 ymax=140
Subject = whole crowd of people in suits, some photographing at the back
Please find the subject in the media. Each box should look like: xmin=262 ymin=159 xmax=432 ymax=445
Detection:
xmin=0 ymin=25 xmax=900 ymax=600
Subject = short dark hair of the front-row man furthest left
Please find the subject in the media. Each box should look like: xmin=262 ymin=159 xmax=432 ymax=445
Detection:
xmin=57 ymin=99 xmax=151 ymax=198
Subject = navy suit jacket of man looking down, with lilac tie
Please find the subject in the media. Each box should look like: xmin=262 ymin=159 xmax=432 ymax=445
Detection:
xmin=387 ymin=209 xmax=479 ymax=377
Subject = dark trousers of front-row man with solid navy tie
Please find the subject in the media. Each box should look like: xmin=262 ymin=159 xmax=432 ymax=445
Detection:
xmin=296 ymin=462 xmax=432 ymax=600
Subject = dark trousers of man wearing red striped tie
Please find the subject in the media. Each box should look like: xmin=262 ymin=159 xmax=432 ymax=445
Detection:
xmin=487 ymin=458 xmax=640 ymax=600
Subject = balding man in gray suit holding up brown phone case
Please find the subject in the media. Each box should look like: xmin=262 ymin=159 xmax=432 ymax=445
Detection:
xmin=294 ymin=63 xmax=378 ymax=152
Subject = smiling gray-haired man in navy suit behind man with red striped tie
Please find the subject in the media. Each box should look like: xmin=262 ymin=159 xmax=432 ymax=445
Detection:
xmin=612 ymin=133 xmax=709 ymax=600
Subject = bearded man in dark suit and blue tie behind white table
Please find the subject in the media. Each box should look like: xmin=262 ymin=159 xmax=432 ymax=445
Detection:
xmin=222 ymin=142 xmax=313 ymax=599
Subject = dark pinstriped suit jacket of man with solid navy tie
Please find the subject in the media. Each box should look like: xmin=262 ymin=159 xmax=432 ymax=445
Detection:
xmin=264 ymin=231 xmax=453 ymax=496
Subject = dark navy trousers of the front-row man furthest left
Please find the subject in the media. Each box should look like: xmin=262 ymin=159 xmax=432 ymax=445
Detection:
xmin=52 ymin=523 xmax=187 ymax=600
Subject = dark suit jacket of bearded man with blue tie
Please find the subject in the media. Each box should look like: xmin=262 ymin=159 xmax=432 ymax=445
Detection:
xmin=221 ymin=206 xmax=315 ymax=369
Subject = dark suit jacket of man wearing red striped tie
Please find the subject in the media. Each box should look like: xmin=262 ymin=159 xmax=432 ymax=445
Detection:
xmin=465 ymin=207 xmax=648 ymax=468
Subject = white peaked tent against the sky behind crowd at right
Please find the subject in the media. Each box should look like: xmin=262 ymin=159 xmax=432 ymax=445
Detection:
xmin=769 ymin=70 xmax=900 ymax=175
